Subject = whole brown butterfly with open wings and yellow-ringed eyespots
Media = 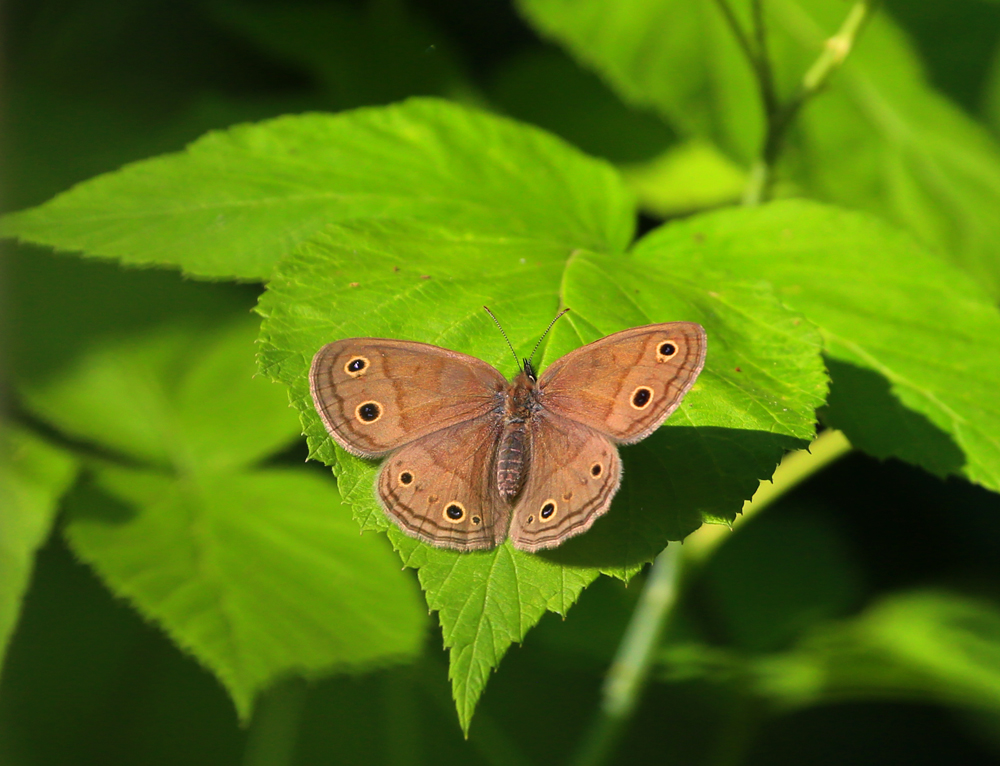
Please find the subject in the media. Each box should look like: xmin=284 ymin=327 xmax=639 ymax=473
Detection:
xmin=309 ymin=309 xmax=707 ymax=551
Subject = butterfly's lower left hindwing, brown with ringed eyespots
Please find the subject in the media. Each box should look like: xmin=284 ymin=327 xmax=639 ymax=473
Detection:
xmin=375 ymin=413 xmax=510 ymax=551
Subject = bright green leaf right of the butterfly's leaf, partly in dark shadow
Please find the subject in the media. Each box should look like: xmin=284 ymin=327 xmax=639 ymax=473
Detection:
xmin=636 ymin=201 xmax=1000 ymax=491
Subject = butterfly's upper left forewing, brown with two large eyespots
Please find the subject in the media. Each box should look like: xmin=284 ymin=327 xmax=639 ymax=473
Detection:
xmin=309 ymin=338 xmax=506 ymax=457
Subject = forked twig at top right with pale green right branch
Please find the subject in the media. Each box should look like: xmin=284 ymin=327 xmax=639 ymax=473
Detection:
xmin=740 ymin=0 xmax=876 ymax=205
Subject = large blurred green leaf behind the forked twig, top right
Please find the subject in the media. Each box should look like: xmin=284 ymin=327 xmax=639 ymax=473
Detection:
xmin=520 ymin=0 xmax=1000 ymax=297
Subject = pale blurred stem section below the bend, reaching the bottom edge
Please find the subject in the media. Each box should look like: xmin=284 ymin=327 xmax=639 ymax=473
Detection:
xmin=574 ymin=543 xmax=681 ymax=766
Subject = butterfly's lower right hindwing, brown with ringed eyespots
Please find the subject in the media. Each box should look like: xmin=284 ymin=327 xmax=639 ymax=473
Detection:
xmin=510 ymin=412 xmax=622 ymax=551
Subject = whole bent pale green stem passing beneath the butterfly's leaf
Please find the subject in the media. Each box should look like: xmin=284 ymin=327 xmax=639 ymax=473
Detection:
xmin=573 ymin=430 xmax=851 ymax=766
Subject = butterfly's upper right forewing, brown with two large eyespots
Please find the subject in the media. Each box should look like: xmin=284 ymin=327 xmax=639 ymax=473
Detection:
xmin=532 ymin=322 xmax=707 ymax=444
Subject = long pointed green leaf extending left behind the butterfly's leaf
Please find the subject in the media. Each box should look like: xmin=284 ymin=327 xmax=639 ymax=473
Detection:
xmin=0 ymin=99 xmax=633 ymax=279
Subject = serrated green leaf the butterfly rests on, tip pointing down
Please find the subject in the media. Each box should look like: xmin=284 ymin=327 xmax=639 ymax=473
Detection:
xmin=259 ymin=220 xmax=826 ymax=729
